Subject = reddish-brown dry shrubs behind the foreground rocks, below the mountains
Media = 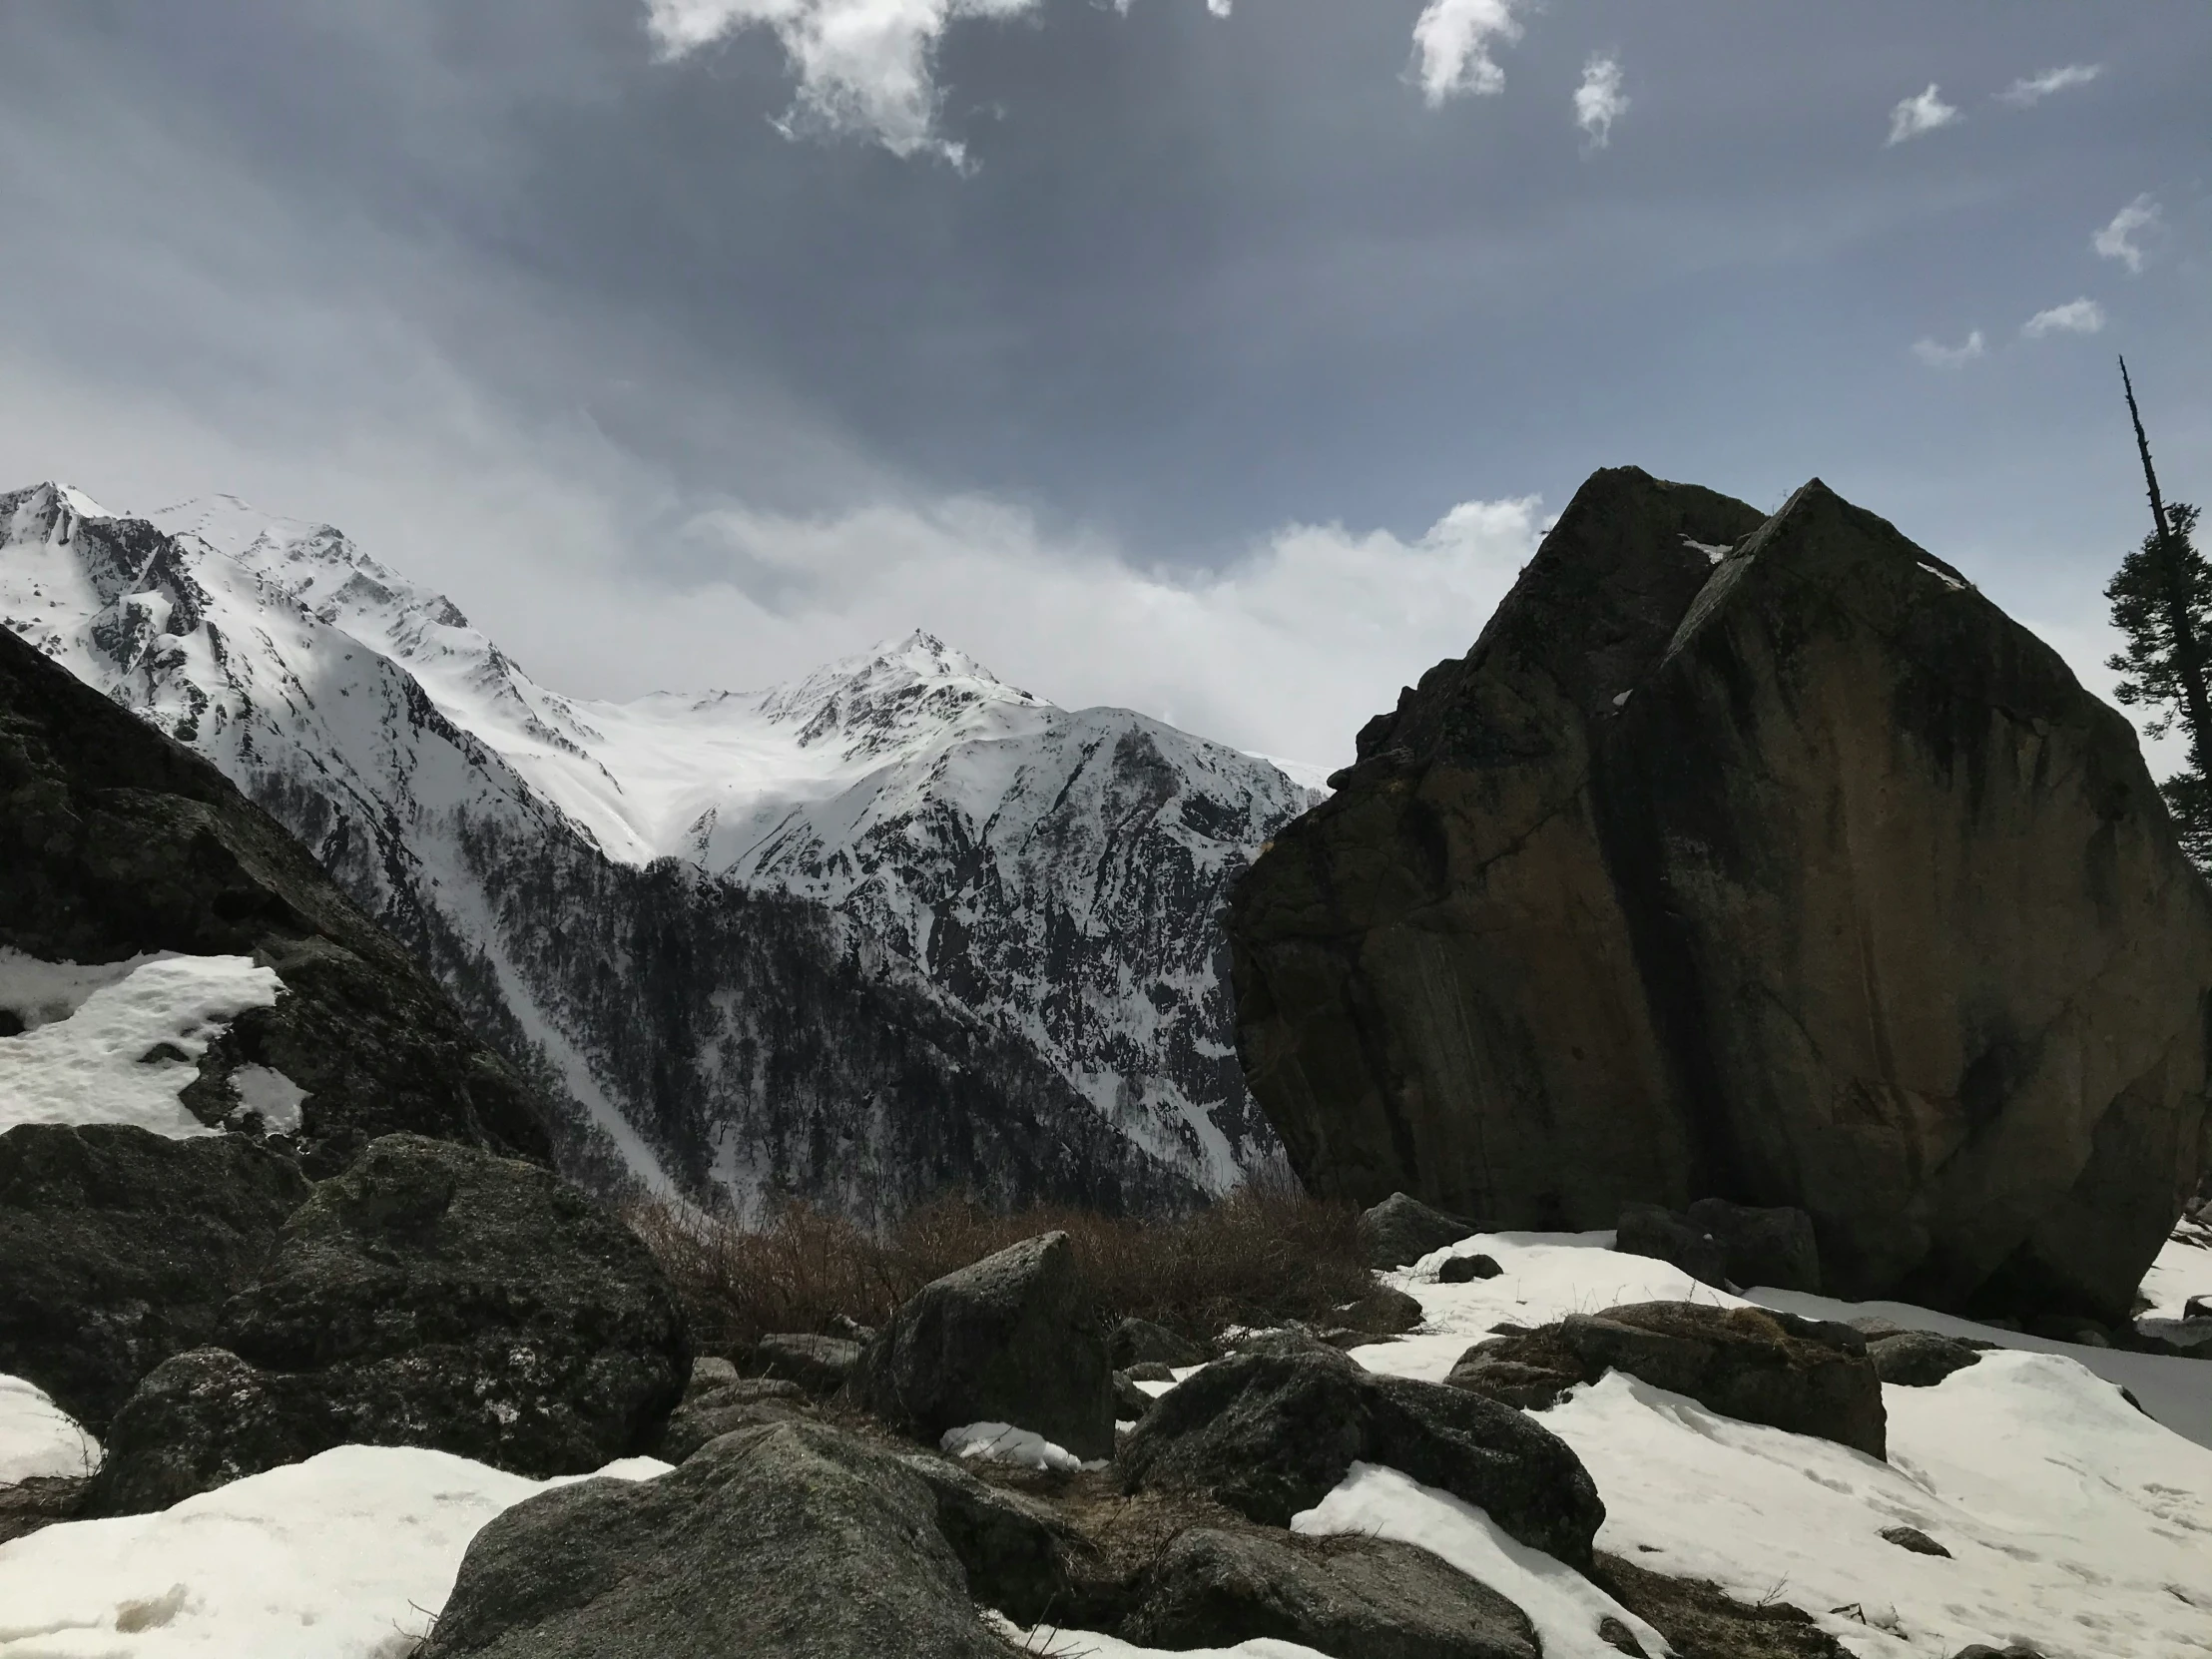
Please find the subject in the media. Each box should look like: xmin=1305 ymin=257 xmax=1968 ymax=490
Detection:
xmin=631 ymin=1184 xmax=1372 ymax=1354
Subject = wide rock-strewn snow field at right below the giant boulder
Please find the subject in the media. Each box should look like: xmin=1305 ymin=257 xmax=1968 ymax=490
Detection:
xmin=1317 ymin=1232 xmax=2212 ymax=1659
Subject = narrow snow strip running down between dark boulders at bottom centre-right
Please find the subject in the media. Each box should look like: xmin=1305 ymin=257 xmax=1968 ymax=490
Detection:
xmin=1290 ymin=1462 xmax=1668 ymax=1659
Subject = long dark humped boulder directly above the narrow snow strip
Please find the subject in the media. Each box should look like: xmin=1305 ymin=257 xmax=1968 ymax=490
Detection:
xmin=1115 ymin=1352 xmax=1606 ymax=1566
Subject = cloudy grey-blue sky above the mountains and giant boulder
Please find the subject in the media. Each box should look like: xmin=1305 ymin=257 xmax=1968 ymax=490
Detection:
xmin=0 ymin=0 xmax=2212 ymax=766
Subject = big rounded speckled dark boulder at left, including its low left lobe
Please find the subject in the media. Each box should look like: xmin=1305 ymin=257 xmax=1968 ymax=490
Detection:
xmin=95 ymin=1135 xmax=690 ymax=1513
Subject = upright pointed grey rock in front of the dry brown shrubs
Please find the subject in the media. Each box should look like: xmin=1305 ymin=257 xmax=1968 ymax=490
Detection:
xmin=849 ymin=1232 xmax=1115 ymax=1457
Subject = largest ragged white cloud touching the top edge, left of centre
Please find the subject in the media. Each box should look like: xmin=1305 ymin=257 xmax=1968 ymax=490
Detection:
xmin=646 ymin=0 xmax=1037 ymax=166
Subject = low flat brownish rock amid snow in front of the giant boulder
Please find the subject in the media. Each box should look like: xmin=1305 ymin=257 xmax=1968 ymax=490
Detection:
xmin=1448 ymin=1303 xmax=1889 ymax=1457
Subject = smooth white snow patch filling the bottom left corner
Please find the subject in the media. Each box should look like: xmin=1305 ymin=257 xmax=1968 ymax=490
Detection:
xmin=0 ymin=1446 xmax=668 ymax=1659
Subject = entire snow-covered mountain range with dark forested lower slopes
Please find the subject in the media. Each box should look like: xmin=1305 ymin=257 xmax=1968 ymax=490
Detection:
xmin=0 ymin=484 xmax=1314 ymax=1212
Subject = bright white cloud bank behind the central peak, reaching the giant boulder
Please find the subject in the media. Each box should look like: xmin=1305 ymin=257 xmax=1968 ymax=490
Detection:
xmin=693 ymin=495 xmax=1539 ymax=766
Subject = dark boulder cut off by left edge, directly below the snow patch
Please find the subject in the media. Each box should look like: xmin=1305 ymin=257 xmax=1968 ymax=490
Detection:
xmin=0 ymin=1123 xmax=309 ymax=1437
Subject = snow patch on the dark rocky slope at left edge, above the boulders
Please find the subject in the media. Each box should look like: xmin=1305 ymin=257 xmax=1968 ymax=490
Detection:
xmin=0 ymin=949 xmax=296 ymax=1139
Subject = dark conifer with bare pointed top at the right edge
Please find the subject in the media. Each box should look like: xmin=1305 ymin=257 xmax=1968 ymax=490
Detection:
xmin=2103 ymin=358 xmax=2212 ymax=869
